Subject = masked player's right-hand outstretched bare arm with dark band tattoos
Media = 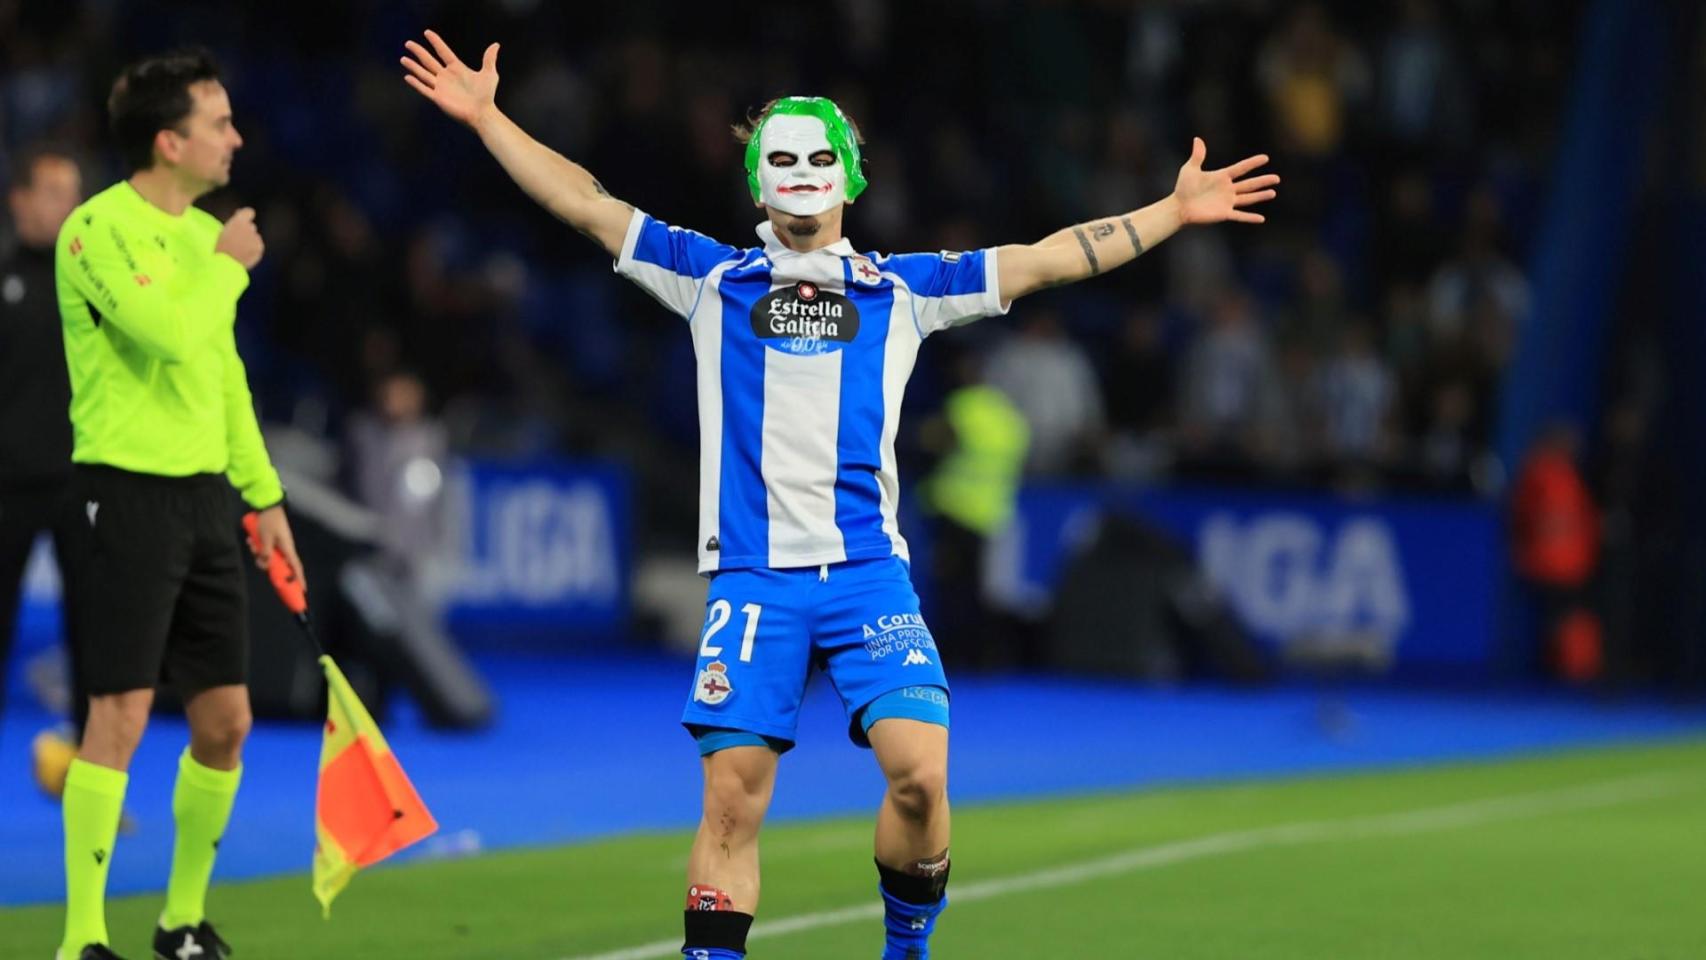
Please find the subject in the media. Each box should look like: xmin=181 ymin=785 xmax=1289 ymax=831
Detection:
xmin=996 ymin=138 xmax=1280 ymax=302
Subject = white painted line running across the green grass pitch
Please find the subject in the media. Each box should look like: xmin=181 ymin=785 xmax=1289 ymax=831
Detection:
xmin=568 ymin=771 xmax=1701 ymax=960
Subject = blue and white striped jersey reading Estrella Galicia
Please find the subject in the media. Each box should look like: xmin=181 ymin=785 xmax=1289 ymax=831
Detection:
xmin=616 ymin=211 xmax=1005 ymax=573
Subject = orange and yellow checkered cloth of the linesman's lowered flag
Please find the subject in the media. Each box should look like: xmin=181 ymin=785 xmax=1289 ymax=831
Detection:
xmin=314 ymin=656 xmax=438 ymax=917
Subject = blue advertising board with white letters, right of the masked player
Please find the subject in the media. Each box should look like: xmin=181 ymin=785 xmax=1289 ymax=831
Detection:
xmin=989 ymin=486 xmax=1505 ymax=677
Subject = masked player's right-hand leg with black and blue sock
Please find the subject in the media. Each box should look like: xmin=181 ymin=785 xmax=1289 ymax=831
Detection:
xmin=868 ymin=718 xmax=949 ymax=960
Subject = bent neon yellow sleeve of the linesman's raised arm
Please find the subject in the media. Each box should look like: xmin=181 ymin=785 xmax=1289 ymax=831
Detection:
xmin=61 ymin=218 xmax=249 ymax=363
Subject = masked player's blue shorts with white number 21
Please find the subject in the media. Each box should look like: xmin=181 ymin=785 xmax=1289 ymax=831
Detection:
xmin=681 ymin=556 xmax=949 ymax=749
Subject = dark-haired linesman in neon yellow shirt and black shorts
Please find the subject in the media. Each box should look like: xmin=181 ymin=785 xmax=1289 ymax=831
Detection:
xmin=56 ymin=49 xmax=302 ymax=960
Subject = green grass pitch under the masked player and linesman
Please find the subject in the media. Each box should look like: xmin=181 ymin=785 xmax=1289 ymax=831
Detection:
xmin=0 ymin=742 xmax=1706 ymax=960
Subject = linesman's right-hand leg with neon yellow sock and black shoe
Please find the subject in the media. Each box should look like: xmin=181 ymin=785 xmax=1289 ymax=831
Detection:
xmin=154 ymin=684 xmax=254 ymax=960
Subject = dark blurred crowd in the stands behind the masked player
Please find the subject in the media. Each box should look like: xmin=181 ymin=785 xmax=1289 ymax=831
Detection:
xmin=0 ymin=0 xmax=1578 ymax=549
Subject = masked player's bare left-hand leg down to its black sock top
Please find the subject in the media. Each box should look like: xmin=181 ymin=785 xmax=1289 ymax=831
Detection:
xmin=686 ymin=747 xmax=776 ymax=957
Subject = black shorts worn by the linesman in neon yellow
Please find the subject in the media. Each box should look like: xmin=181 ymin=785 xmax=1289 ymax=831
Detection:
xmin=68 ymin=464 xmax=249 ymax=701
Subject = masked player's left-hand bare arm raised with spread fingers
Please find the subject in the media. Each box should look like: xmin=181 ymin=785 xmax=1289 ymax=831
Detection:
xmin=403 ymin=31 xmax=633 ymax=256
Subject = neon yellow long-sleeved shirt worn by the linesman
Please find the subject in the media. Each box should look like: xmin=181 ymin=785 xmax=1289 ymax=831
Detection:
xmin=55 ymin=181 xmax=285 ymax=510
